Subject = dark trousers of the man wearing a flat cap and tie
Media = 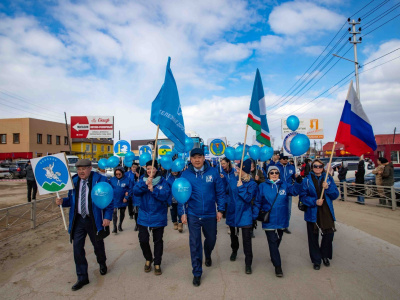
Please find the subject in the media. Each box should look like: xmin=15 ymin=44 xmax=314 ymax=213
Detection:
xmin=72 ymin=214 xmax=107 ymax=280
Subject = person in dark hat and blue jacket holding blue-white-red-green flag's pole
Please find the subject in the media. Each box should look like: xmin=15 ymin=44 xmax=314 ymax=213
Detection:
xmin=226 ymin=159 xmax=257 ymax=274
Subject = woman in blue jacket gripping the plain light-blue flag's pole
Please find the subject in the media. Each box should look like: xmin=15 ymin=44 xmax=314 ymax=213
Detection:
xmin=133 ymin=161 xmax=171 ymax=275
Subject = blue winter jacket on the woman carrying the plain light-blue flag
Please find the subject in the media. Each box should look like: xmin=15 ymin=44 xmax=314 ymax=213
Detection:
xmin=133 ymin=177 xmax=171 ymax=228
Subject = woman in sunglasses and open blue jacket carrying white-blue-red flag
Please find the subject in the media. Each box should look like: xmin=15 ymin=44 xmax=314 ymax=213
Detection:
xmin=300 ymin=159 xmax=339 ymax=270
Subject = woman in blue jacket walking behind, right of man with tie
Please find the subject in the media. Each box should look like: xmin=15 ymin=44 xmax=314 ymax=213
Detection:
xmin=110 ymin=167 xmax=134 ymax=233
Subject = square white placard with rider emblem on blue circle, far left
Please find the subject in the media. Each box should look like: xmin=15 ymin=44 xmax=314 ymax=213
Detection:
xmin=31 ymin=153 xmax=74 ymax=195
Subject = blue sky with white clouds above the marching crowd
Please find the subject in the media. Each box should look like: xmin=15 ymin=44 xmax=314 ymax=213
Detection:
xmin=0 ymin=0 xmax=400 ymax=148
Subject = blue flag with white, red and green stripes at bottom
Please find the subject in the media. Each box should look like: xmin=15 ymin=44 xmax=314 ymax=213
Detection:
xmin=246 ymin=69 xmax=271 ymax=147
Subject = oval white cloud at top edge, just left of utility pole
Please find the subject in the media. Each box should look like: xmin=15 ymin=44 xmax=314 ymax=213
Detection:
xmin=268 ymin=1 xmax=346 ymax=35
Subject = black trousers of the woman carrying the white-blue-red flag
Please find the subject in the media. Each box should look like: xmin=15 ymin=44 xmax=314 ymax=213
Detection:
xmin=307 ymin=222 xmax=334 ymax=265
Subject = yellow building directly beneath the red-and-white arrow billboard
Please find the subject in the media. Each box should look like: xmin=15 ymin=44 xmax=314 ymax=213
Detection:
xmin=72 ymin=139 xmax=114 ymax=161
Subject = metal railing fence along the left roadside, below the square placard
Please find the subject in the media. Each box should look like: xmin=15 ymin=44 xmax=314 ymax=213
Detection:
xmin=0 ymin=193 xmax=68 ymax=240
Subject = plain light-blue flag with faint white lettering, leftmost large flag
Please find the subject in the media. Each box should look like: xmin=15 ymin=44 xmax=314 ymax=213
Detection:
xmin=150 ymin=57 xmax=186 ymax=153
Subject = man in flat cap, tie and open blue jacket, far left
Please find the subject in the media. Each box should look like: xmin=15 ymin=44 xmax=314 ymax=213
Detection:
xmin=56 ymin=159 xmax=114 ymax=291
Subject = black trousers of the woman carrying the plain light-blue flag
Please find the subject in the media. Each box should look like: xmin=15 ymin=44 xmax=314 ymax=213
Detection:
xmin=138 ymin=225 xmax=164 ymax=265
